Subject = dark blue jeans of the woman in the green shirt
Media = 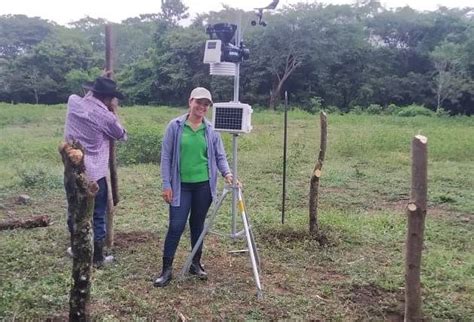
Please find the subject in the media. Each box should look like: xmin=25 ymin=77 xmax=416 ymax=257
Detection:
xmin=163 ymin=181 xmax=212 ymax=257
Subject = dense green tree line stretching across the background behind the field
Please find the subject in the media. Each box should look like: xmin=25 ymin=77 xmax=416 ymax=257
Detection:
xmin=0 ymin=0 xmax=474 ymax=115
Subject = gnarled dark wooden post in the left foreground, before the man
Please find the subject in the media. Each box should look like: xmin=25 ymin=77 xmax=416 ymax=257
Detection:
xmin=59 ymin=142 xmax=99 ymax=321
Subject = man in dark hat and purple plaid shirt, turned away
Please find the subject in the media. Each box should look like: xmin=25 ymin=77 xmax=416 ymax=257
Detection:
xmin=64 ymin=77 xmax=127 ymax=267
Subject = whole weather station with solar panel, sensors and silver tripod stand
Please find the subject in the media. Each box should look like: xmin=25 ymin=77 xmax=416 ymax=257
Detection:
xmin=180 ymin=0 xmax=278 ymax=298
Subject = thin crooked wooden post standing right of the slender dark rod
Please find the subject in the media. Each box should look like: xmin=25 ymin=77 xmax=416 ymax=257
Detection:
xmin=309 ymin=111 xmax=328 ymax=233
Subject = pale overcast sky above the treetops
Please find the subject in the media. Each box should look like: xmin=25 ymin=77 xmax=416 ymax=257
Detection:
xmin=0 ymin=0 xmax=474 ymax=25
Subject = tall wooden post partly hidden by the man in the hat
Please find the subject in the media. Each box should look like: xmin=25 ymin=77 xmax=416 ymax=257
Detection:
xmin=105 ymin=25 xmax=119 ymax=248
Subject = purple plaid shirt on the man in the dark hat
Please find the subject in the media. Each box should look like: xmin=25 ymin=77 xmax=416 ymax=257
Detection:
xmin=64 ymin=95 xmax=127 ymax=181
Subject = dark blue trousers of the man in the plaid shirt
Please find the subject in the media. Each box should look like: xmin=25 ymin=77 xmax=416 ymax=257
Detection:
xmin=67 ymin=177 xmax=107 ymax=241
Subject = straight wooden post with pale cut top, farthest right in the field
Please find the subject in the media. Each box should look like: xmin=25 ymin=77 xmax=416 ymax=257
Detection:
xmin=405 ymin=135 xmax=428 ymax=321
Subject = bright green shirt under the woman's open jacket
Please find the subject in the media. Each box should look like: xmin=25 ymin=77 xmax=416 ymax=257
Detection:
xmin=179 ymin=122 xmax=209 ymax=183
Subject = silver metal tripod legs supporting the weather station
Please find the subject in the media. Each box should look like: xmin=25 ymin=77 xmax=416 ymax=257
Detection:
xmin=180 ymin=180 xmax=263 ymax=299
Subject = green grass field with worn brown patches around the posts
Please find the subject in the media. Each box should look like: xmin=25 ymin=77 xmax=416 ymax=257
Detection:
xmin=0 ymin=104 xmax=474 ymax=321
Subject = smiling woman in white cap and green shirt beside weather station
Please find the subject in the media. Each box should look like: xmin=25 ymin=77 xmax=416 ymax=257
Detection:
xmin=154 ymin=87 xmax=233 ymax=287
